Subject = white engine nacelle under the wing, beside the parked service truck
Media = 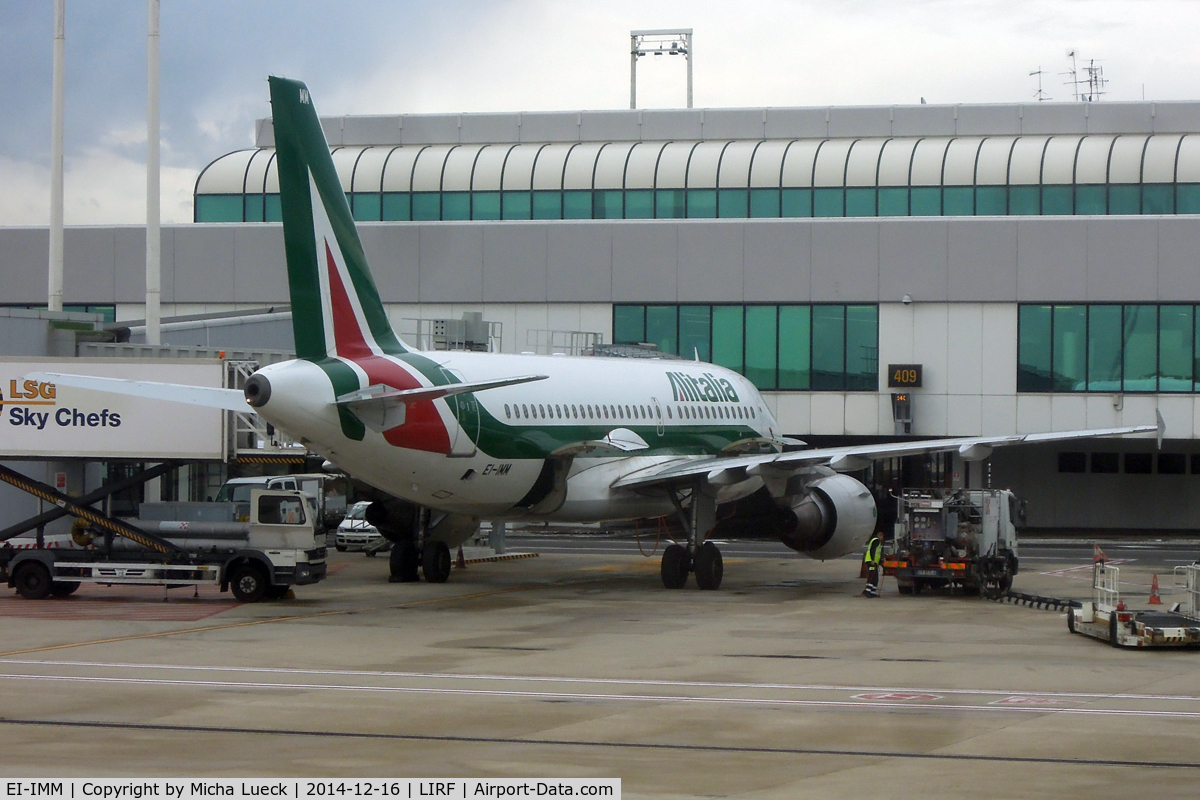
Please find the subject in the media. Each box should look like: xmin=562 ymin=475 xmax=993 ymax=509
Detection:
xmin=779 ymin=475 xmax=878 ymax=561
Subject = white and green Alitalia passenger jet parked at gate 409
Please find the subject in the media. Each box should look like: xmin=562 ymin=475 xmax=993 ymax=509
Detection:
xmin=31 ymin=78 xmax=1163 ymax=589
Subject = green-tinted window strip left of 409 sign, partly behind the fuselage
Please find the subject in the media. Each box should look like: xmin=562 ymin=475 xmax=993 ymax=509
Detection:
xmin=612 ymin=305 xmax=880 ymax=391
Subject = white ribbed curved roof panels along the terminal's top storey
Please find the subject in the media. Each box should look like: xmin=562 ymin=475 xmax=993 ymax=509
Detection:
xmin=196 ymin=133 xmax=1200 ymax=196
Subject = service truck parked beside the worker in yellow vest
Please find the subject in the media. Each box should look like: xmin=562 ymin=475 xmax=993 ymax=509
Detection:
xmin=883 ymin=489 xmax=1025 ymax=596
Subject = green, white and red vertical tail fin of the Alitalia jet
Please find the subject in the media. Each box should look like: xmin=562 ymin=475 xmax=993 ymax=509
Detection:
xmin=270 ymin=76 xmax=408 ymax=359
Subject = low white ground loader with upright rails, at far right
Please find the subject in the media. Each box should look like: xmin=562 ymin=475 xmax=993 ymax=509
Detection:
xmin=1067 ymin=560 xmax=1200 ymax=648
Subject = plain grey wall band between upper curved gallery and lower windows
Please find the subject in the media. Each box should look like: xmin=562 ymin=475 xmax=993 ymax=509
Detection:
xmin=9 ymin=216 xmax=1200 ymax=306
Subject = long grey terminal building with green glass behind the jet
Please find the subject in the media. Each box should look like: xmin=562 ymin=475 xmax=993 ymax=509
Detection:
xmin=0 ymin=102 xmax=1200 ymax=531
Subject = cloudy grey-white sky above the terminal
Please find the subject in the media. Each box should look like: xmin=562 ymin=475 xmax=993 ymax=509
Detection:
xmin=0 ymin=0 xmax=1200 ymax=225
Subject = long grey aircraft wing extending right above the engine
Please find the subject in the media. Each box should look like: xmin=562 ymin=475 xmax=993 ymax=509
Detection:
xmin=613 ymin=411 xmax=1166 ymax=488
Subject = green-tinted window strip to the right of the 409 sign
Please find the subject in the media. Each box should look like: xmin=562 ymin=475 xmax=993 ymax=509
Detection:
xmin=1016 ymin=303 xmax=1200 ymax=392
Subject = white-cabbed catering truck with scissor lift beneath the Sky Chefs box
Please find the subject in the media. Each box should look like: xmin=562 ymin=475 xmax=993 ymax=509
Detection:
xmin=0 ymin=489 xmax=325 ymax=602
